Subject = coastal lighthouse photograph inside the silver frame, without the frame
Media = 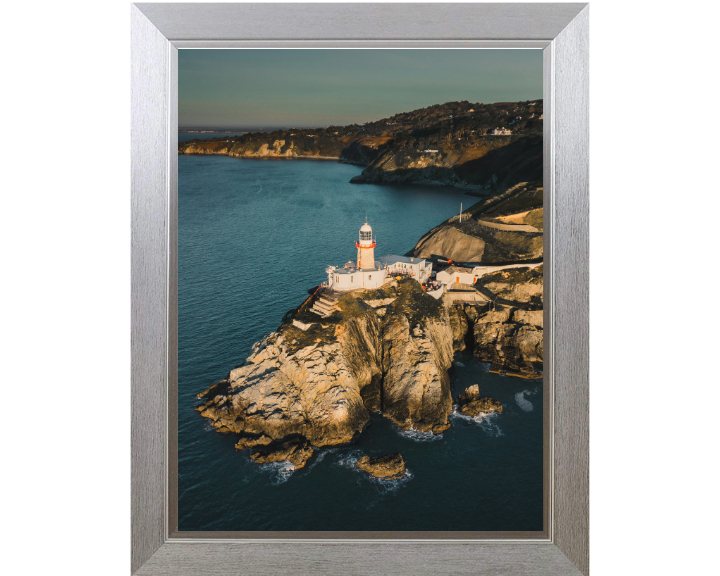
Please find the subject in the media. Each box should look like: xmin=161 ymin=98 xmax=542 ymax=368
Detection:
xmin=177 ymin=49 xmax=544 ymax=532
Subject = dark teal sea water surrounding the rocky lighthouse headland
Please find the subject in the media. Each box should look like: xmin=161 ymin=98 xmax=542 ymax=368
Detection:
xmin=178 ymin=142 xmax=543 ymax=531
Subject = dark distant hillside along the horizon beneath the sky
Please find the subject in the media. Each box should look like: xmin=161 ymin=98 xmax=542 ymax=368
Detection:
xmin=178 ymin=100 xmax=543 ymax=193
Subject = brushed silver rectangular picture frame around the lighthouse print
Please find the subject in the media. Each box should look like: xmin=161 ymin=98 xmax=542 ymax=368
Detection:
xmin=131 ymin=3 xmax=589 ymax=576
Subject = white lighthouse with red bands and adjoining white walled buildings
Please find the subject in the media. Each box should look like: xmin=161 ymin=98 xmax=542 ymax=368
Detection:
xmin=325 ymin=222 xmax=432 ymax=292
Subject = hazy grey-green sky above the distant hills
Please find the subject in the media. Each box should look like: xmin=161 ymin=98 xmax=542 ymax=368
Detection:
xmin=178 ymin=49 xmax=542 ymax=128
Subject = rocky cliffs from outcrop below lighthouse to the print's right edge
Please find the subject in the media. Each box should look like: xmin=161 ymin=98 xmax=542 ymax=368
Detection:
xmin=197 ymin=268 xmax=542 ymax=468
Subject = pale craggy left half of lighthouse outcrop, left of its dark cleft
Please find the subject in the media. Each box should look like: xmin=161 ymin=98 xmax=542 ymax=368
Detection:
xmin=193 ymin=312 xmax=382 ymax=446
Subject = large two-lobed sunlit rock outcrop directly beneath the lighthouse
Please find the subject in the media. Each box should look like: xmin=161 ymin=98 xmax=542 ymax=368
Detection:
xmin=197 ymin=279 xmax=453 ymax=462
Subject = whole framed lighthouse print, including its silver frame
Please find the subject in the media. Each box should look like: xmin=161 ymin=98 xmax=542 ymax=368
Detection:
xmin=132 ymin=3 xmax=588 ymax=575
